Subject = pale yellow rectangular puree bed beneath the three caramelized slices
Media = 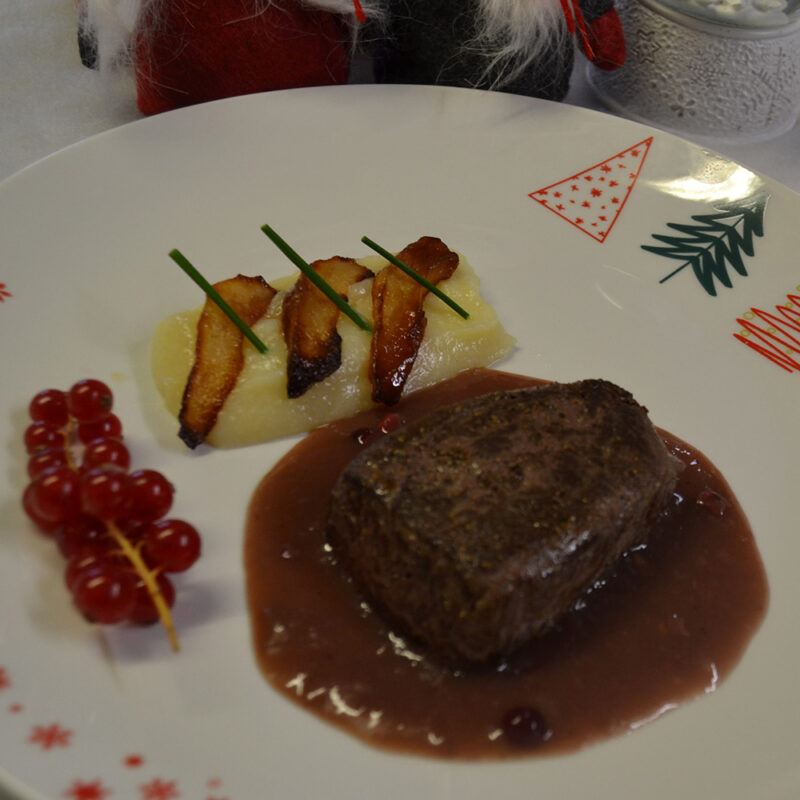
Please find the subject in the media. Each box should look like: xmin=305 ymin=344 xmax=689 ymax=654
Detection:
xmin=152 ymin=238 xmax=514 ymax=448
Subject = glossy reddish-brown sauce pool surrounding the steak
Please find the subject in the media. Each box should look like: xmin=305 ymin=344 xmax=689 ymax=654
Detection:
xmin=245 ymin=369 xmax=768 ymax=759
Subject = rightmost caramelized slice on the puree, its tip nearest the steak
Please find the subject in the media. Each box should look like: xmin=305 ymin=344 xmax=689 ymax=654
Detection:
xmin=369 ymin=236 xmax=458 ymax=405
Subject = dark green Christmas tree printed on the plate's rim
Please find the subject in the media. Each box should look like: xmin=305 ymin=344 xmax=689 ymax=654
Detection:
xmin=642 ymin=192 xmax=769 ymax=296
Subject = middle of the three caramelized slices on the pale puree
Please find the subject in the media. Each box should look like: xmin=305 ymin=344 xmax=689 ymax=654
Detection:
xmin=281 ymin=256 xmax=372 ymax=398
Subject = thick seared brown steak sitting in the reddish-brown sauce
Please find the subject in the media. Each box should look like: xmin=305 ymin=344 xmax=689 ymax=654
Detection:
xmin=328 ymin=380 xmax=680 ymax=663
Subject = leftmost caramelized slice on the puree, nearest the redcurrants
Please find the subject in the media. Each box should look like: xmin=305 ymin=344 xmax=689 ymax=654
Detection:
xmin=178 ymin=275 xmax=276 ymax=449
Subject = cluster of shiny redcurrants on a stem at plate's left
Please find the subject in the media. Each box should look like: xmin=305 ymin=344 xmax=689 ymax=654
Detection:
xmin=22 ymin=378 xmax=201 ymax=644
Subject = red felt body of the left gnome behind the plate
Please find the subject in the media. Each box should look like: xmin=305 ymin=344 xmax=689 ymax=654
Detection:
xmin=133 ymin=0 xmax=363 ymax=114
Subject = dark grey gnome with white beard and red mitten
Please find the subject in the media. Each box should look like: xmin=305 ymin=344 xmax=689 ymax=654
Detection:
xmin=375 ymin=0 xmax=625 ymax=100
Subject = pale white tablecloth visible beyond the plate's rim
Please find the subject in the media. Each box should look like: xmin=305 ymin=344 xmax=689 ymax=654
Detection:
xmin=0 ymin=0 xmax=800 ymax=192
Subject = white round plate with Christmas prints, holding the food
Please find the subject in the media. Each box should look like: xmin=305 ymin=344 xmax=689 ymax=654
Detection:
xmin=0 ymin=86 xmax=800 ymax=800
